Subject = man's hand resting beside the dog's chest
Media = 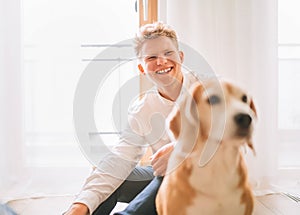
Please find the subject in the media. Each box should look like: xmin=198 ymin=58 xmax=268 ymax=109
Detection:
xmin=150 ymin=143 xmax=174 ymax=176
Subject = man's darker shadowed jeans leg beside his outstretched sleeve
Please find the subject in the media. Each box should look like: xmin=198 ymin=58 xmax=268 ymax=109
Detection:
xmin=93 ymin=167 xmax=154 ymax=215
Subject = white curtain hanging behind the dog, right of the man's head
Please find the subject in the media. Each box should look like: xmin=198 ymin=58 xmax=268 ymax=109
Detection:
xmin=166 ymin=0 xmax=278 ymax=188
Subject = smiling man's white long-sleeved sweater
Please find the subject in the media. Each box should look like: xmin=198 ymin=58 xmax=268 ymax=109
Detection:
xmin=75 ymin=72 xmax=197 ymax=213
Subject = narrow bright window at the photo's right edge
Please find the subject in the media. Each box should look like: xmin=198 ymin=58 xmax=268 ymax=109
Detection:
xmin=278 ymin=0 xmax=300 ymax=169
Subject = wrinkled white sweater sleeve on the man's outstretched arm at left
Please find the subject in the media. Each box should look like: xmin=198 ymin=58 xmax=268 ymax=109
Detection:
xmin=75 ymin=122 xmax=146 ymax=214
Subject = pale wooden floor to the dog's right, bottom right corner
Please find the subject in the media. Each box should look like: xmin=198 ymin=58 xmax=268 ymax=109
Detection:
xmin=253 ymin=194 xmax=300 ymax=215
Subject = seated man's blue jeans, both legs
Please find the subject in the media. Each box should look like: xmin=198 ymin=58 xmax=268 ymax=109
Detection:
xmin=93 ymin=167 xmax=162 ymax=215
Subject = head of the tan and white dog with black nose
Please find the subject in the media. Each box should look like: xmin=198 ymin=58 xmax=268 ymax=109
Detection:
xmin=169 ymin=80 xmax=257 ymax=155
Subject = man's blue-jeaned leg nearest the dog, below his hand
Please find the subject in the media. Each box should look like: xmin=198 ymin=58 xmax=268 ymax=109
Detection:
xmin=114 ymin=177 xmax=163 ymax=215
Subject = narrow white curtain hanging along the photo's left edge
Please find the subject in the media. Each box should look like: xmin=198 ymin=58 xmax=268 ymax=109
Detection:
xmin=0 ymin=0 xmax=23 ymax=197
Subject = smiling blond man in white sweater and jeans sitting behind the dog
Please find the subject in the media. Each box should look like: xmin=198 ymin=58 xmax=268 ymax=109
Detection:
xmin=65 ymin=22 xmax=196 ymax=215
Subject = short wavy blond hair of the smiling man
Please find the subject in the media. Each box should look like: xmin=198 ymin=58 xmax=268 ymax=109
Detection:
xmin=135 ymin=22 xmax=178 ymax=57
